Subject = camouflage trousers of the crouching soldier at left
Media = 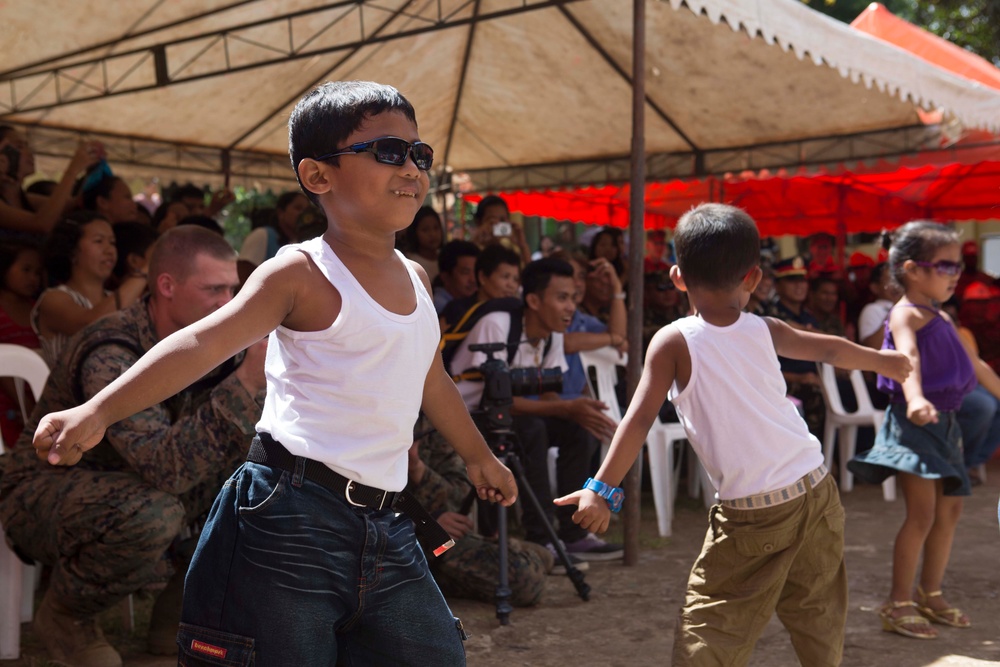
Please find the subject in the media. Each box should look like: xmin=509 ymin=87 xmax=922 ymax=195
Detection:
xmin=0 ymin=469 xmax=229 ymax=615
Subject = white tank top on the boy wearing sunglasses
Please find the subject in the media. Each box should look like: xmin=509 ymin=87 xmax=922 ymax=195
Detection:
xmin=257 ymin=237 xmax=441 ymax=491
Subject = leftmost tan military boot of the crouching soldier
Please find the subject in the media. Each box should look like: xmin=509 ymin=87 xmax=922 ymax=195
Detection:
xmin=34 ymin=589 xmax=122 ymax=667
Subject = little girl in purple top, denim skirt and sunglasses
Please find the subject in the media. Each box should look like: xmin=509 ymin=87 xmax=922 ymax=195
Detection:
xmin=848 ymin=222 xmax=1000 ymax=639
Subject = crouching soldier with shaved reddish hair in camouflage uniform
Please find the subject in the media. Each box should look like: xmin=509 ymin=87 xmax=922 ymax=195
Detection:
xmin=0 ymin=226 xmax=265 ymax=666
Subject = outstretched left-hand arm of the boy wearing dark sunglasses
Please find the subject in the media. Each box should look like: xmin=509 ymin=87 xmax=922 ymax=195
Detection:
xmin=32 ymin=253 xmax=303 ymax=465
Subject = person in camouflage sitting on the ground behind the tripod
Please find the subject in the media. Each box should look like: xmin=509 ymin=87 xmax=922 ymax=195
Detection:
xmin=407 ymin=420 xmax=553 ymax=606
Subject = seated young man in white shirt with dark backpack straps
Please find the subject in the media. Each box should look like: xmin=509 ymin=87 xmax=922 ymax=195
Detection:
xmin=450 ymin=257 xmax=622 ymax=561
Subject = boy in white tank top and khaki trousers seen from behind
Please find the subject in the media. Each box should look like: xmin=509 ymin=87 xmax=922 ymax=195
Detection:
xmin=556 ymin=204 xmax=910 ymax=667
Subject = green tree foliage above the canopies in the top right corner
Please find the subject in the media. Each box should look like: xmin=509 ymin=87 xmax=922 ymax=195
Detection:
xmin=802 ymin=0 xmax=1000 ymax=66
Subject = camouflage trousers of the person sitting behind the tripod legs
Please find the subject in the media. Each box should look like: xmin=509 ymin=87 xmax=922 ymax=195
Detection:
xmin=431 ymin=534 xmax=553 ymax=607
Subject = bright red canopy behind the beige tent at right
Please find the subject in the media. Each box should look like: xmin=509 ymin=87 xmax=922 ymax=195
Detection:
xmin=465 ymin=3 xmax=1000 ymax=236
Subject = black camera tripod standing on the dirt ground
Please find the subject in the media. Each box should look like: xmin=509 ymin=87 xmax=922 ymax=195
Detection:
xmin=472 ymin=413 xmax=590 ymax=625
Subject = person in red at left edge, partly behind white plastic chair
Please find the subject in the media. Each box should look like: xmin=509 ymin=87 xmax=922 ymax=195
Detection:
xmin=0 ymin=241 xmax=42 ymax=447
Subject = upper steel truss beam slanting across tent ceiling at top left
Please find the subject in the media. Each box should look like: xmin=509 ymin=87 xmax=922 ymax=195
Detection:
xmin=0 ymin=0 xmax=580 ymax=116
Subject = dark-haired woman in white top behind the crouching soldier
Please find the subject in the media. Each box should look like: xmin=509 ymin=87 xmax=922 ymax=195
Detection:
xmin=31 ymin=211 xmax=146 ymax=368
